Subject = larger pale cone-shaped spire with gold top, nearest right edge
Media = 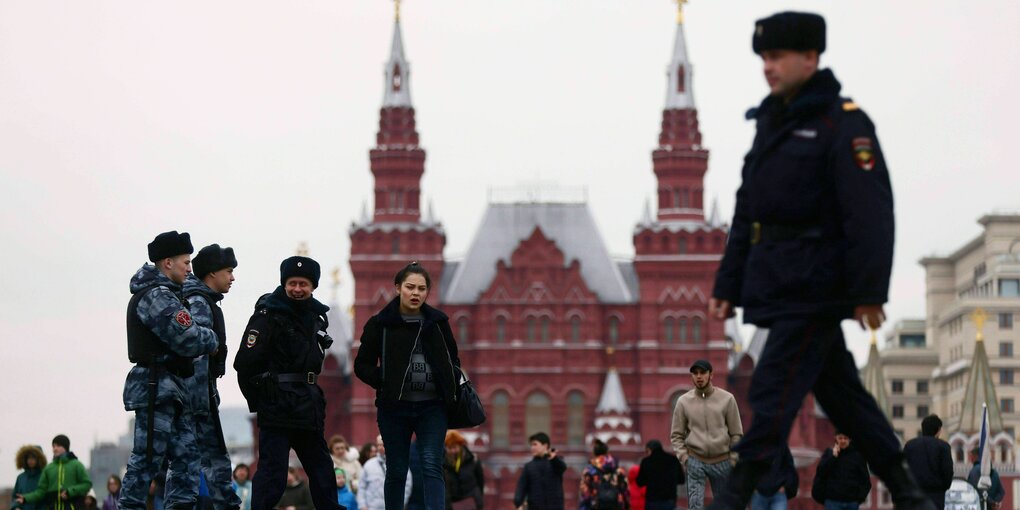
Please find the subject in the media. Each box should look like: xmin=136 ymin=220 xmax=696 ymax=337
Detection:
xmin=959 ymin=308 xmax=1003 ymax=435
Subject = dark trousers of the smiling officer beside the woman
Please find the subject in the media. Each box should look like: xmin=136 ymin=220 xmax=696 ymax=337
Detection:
xmin=252 ymin=428 xmax=343 ymax=510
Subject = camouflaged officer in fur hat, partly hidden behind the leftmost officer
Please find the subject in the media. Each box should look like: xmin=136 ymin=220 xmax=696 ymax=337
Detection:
xmin=184 ymin=245 xmax=241 ymax=510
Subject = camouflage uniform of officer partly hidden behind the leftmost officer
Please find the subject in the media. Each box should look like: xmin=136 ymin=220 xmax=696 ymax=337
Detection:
xmin=184 ymin=274 xmax=241 ymax=510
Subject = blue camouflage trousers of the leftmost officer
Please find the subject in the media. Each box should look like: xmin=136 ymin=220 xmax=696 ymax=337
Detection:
xmin=118 ymin=401 xmax=200 ymax=510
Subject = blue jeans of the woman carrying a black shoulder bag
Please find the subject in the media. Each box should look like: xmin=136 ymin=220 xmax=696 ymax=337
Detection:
xmin=375 ymin=400 xmax=447 ymax=510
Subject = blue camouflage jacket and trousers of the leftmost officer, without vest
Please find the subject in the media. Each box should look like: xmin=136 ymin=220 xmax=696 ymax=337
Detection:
xmin=118 ymin=264 xmax=217 ymax=510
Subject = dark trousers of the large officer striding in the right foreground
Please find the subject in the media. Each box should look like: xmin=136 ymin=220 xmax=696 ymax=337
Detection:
xmin=727 ymin=318 xmax=903 ymax=508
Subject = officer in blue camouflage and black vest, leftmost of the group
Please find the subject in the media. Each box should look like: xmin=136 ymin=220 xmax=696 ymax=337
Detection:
xmin=118 ymin=231 xmax=218 ymax=510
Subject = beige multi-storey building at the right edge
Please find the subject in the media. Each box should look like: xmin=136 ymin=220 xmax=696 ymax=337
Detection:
xmin=862 ymin=214 xmax=1020 ymax=474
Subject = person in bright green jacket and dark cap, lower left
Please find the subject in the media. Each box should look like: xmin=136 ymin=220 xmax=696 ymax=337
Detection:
xmin=14 ymin=434 xmax=92 ymax=510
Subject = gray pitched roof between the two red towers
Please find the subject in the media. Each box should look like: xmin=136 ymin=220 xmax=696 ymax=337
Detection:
xmin=443 ymin=203 xmax=636 ymax=303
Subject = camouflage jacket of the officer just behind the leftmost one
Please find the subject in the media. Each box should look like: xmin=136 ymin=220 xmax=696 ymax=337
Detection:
xmin=184 ymin=273 xmax=226 ymax=416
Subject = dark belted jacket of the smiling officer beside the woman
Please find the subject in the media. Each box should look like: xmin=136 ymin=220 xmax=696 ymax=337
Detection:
xmin=234 ymin=287 xmax=333 ymax=430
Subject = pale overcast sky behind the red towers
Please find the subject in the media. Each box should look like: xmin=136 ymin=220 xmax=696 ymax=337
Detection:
xmin=0 ymin=0 xmax=1020 ymax=487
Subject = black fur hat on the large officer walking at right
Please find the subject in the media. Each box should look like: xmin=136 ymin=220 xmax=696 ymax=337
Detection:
xmin=751 ymin=11 xmax=825 ymax=54
